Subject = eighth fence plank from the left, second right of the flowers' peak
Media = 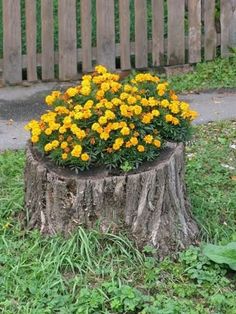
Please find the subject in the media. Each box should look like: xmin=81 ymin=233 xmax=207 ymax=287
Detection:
xmin=134 ymin=0 xmax=148 ymax=69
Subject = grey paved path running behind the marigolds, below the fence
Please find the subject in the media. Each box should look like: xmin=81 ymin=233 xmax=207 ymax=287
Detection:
xmin=0 ymin=83 xmax=236 ymax=151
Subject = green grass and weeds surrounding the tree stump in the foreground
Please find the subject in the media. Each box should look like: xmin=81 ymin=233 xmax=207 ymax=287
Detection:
xmin=0 ymin=122 xmax=236 ymax=314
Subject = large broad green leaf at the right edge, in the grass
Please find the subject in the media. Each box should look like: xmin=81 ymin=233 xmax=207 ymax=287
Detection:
xmin=203 ymin=242 xmax=236 ymax=270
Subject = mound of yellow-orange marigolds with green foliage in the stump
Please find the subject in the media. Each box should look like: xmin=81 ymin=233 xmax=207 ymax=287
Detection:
xmin=26 ymin=65 xmax=197 ymax=170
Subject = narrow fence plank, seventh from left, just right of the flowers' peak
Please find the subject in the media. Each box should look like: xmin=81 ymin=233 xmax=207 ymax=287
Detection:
xmin=119 ymin=0 xmax=131 ymax=70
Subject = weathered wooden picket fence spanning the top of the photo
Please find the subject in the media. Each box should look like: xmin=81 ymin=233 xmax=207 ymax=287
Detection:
xmin=0 ymin=0 xmax=236 ymax=84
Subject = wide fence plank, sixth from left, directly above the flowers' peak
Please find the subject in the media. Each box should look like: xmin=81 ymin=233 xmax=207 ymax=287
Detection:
xmin=96 ymin=0 xmax=116 ymax=70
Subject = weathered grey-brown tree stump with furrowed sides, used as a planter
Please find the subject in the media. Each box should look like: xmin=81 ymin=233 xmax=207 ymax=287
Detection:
xmin=25 ymin=143 xmax=198 ymax=257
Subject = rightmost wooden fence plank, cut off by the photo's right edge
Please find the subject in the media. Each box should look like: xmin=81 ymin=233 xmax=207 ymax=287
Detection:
xmin=220 ymin=0 xmax=236 ymax=57
